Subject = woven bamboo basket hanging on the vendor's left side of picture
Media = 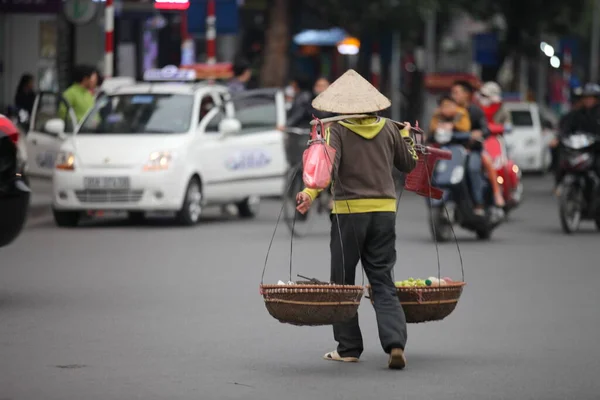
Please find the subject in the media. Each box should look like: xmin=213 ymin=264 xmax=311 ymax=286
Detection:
xmin=260 ymin=282 xmax=365 ymax=326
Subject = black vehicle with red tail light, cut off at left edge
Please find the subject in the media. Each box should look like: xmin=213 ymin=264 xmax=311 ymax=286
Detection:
xmin=0 ymin=115 xmax=31 ymax=247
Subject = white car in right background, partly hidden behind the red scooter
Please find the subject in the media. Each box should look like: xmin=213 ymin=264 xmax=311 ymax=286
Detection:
xmin=504 ymin=102 xmax=556 ymax=172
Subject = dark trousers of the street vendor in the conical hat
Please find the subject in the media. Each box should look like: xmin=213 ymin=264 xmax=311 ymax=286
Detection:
xmin=330 ymin=212 xmax=406 ymax=357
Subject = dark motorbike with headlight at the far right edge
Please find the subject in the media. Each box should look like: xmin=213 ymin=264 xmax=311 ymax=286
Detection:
xmin=558 ymin=132 xmax=600 ymax=234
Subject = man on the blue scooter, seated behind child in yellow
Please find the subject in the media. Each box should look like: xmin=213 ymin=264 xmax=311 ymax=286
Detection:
xmin=451 ymin=81 xmax=505 ymax=216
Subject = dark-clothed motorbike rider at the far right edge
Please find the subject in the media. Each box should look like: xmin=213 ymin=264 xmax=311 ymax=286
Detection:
xmin=556 ymin=83 xmax=600 ymax=191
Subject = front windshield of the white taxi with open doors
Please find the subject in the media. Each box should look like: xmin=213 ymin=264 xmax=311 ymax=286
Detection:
xmin=79 ymin=93 xmax=194 ymax=134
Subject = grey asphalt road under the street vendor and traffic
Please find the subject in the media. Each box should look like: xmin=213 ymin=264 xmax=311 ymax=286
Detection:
xmin=0 ymin=178 xmax=600 ymax=400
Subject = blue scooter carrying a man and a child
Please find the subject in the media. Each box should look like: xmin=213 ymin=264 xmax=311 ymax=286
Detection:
xmin=430 ymin=130 xmax=504 ymax=242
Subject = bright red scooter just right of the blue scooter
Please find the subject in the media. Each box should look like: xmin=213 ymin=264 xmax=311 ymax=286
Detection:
xmin=483 ymin=122 xmax=523 ymax=215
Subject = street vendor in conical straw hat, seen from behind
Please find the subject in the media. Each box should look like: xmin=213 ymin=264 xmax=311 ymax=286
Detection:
xmin=296 ymin=70 xmax=417 ymax=369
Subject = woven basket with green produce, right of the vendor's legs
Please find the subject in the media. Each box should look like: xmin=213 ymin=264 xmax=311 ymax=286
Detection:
xmin=367 ymin=282 xmax=465 ymax=324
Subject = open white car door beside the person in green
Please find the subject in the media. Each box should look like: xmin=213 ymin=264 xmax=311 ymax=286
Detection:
xmin=26 ymin=92 xmax=77 ymax=178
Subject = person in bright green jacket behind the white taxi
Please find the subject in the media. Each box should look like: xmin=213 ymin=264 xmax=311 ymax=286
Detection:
xmin=58 ymin=65 xmax=98 ymax=122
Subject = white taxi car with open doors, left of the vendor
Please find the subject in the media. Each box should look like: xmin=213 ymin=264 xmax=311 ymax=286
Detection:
xmin=29 ymin=67 xmax=288 ymax=226
